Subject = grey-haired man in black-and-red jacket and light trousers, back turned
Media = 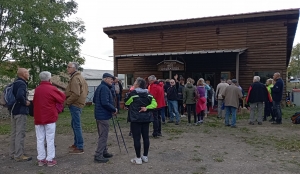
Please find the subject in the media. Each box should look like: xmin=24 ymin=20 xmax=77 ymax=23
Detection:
xmin=246 ymin=76 xmax=272 ymax=125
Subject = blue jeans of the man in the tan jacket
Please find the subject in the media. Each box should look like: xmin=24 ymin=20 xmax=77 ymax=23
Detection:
xmin=69 ymin=105 xmax=83 ymax=149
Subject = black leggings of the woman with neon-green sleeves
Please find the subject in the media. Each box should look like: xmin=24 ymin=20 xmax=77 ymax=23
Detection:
xmin=130 ymin=122 xmax=150 ymax=158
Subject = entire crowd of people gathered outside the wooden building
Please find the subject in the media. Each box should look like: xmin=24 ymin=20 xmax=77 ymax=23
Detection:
xmin=9 ymin=62 xmax=284 ymax=166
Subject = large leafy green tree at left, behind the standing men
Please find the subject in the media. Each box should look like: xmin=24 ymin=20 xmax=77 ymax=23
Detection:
xmin=0 ymin=0 xmax=85 ymax=87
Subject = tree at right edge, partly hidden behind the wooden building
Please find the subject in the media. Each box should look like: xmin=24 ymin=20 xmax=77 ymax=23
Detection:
xmin=288 ymin=43 xmax=300 ymax=76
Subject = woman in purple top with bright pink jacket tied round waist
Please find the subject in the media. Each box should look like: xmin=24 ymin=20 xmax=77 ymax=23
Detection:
xmin=196 ymin=78 xmax=207 ymax=124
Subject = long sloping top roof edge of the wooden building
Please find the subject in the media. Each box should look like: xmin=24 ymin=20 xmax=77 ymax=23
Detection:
xmin=103 ymin=8 xmax=299 ymax=35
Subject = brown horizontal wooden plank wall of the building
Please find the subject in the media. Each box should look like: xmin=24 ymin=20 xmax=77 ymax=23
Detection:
xmin=114 ymin=19 xmax=287 ymax=92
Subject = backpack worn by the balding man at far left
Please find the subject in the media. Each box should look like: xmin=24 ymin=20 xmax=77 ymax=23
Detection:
xmin=0 ymin=80 xmax=22 ymax=108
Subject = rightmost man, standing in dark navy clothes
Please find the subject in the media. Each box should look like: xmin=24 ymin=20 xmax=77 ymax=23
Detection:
xmin=271 ymin=72 xmax=284 ymax=124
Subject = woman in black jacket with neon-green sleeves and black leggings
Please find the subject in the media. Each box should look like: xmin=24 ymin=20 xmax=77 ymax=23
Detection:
xmin=125 ymin=78 xmax=157 ymax=164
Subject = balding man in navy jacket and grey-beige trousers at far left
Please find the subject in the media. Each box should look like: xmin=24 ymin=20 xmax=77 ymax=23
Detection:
xmin=9 ymin=68 xmax=32 ymax=161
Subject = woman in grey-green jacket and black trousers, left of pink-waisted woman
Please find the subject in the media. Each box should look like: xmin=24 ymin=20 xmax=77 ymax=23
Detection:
xmin=183 ymin=78 xmax=197 ymax=126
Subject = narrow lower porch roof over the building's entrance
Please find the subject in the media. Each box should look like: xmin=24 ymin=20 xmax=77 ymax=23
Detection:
xmin=115 ymin=48 xmax=247 ymax=58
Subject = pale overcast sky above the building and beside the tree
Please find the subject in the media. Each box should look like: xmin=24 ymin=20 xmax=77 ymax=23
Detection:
xmin=72 ymin=0 xmax=300 ymax=70
